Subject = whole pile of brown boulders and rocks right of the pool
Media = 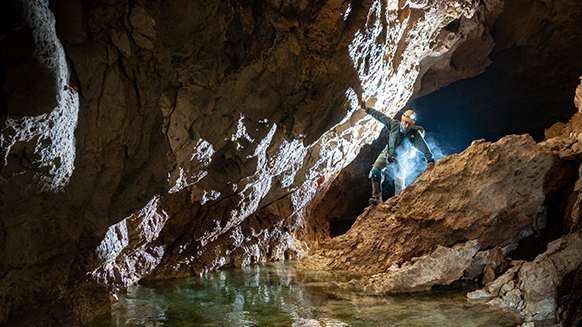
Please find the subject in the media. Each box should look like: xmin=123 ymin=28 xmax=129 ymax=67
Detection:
xmin=296 ymin=76 xmax=582 ymax=326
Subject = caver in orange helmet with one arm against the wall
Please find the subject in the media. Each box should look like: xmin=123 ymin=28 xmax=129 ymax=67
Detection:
xmin=360 ymin=100 xmax=435 ymax=205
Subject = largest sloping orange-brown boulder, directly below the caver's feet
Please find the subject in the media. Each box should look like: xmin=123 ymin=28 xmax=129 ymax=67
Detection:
xmin=297 ymin=135 xmax=574 ymax=274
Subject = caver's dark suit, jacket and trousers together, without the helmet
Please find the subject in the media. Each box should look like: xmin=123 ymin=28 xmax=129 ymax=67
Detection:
xmin=366 ymin=108 xmax=434 ymax=199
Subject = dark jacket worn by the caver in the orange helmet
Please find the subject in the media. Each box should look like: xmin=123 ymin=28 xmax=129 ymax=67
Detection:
xmin=366 ymin=108 xmax=434 ymax=162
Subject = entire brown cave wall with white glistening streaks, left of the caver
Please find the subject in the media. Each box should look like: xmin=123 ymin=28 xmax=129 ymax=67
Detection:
xmin=0 ymin=0 xmax=580 ymax=326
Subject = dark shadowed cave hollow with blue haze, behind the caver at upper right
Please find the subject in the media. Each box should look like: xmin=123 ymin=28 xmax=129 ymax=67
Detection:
xmin=415 ymin=0 xmax=582 ymax=152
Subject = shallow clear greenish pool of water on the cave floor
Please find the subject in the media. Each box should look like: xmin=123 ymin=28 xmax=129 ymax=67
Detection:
xmin=89 ymin=262 xmax=523 ymax=327
